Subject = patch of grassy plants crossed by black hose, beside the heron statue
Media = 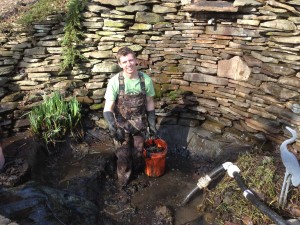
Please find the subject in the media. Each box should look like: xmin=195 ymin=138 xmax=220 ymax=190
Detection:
xmin=204 ymin=153 xmax=279 ymax=225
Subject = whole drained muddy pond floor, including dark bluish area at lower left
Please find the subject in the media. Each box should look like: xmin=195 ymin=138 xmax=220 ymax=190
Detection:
xmin=0 ymin=130 xmax=213 ymax=225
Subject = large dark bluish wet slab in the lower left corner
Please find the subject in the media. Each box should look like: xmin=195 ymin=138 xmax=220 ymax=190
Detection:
xmin=0 ymin=182 xmax=98 ymax=225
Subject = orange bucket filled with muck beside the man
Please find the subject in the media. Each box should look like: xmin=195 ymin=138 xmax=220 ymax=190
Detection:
xmin=143 ymin=139 xmax=168 ymax=177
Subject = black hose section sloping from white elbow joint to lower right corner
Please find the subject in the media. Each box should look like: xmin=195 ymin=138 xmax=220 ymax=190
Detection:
xmin=233 ymin=172 xmax=288 ymax=225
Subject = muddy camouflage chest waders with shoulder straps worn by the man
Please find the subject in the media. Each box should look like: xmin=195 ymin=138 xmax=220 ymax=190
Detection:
xmin=114 ymin=72 xmax=147 ymax=186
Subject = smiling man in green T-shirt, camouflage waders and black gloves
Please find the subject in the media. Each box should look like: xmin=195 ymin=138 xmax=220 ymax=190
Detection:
xmin=103 ymin=47 xmax=157 ymax=186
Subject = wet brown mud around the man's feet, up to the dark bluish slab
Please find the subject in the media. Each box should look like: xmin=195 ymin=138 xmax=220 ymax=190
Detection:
xmin=3 ymin=130 xmax=213 ymax=225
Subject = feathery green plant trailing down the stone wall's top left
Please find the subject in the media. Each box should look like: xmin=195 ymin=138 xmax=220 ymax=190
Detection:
xmin=61 ymin=0 xmax=86 ymax=71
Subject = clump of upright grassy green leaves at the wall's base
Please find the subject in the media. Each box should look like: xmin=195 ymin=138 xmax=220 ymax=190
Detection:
xmin=29 ymin=92 xmax=81 ymax=148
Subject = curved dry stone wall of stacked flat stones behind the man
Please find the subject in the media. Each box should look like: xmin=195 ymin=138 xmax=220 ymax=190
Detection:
xmin=0 ymin=0 xmax=300 ymax=147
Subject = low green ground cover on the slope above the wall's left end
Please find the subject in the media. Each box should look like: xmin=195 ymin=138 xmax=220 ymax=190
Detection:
xmin=18 ymin=0 xmax=66 ymax=26
